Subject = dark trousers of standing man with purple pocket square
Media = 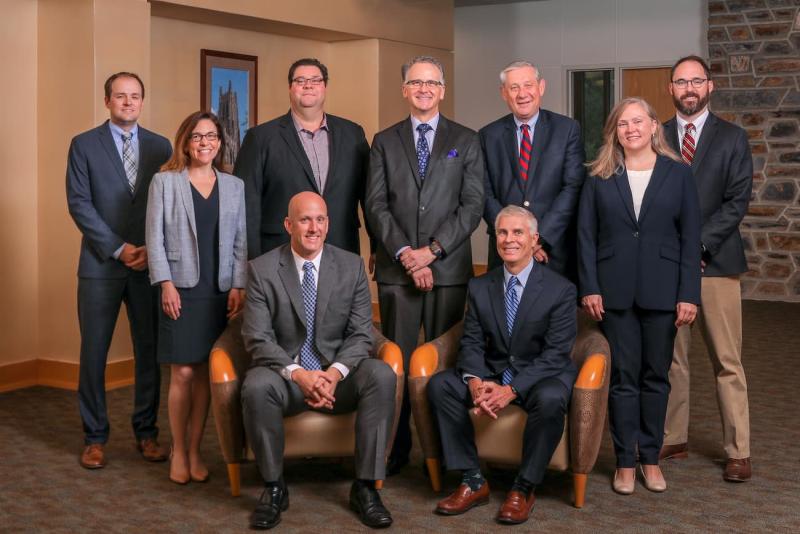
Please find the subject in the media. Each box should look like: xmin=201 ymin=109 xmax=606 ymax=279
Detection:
xmin=378 ymin=284 xmax=467 ymax=459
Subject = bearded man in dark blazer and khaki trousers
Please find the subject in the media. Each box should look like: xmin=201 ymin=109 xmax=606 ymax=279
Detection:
xmin=661 ymin=56 xmax=753 ymax=482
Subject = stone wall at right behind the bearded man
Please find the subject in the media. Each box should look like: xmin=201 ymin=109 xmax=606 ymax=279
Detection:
xmin=708 ymin=0 xmax=800 ymax=302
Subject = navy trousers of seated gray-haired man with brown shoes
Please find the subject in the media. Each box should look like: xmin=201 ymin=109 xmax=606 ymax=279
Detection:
xmin=428 ymin=369 xmax=571 ymax=485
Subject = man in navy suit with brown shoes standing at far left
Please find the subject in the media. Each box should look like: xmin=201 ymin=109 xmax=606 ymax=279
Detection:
xmin=67 ymin=72 xmax=172 ymax=469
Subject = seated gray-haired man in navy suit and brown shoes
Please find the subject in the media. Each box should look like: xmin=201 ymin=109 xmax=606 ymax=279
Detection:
xmin=428 ymin=206 xmax=578 ymax=524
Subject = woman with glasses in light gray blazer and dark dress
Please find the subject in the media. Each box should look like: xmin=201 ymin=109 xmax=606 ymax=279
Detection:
xmin=146 ymin=111 xmax=247 ymax=484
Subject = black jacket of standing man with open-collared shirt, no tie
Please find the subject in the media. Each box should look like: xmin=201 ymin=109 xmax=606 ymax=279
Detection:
xmin=233 ymin=112 xmax=369 ymax=258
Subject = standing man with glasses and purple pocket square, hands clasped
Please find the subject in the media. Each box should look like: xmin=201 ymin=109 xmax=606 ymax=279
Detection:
xmin=366 ymin=56 xmax=483 ymax=474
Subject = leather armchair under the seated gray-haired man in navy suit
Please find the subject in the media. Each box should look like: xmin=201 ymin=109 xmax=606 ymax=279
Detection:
xmin=408 ymin=311 xmax=611 ymax=508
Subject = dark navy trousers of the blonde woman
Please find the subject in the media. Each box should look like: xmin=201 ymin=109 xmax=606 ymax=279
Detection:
xmin=600 ymin=305 xmax=675 ymax=467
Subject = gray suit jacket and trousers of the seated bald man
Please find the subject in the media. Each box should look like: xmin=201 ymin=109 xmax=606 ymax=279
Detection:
xmin=242 ymin=244 xmax=396 ymax=482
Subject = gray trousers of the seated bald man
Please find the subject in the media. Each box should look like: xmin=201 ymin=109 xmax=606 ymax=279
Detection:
xmin=242 ymin=358 xmax=397 ymax=483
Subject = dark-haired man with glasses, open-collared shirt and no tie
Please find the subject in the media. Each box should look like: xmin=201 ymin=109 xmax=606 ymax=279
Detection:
xmin=233 ymin=58 xmax=369 ymax=258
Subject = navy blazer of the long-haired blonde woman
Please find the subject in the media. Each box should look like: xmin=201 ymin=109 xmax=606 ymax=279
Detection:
xmin=578 ymin=156 xmax=700 ymax=311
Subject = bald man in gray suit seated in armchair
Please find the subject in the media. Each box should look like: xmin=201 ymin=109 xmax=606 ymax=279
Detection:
xmin=242 ymin=191 xmax=396 ymax=529
